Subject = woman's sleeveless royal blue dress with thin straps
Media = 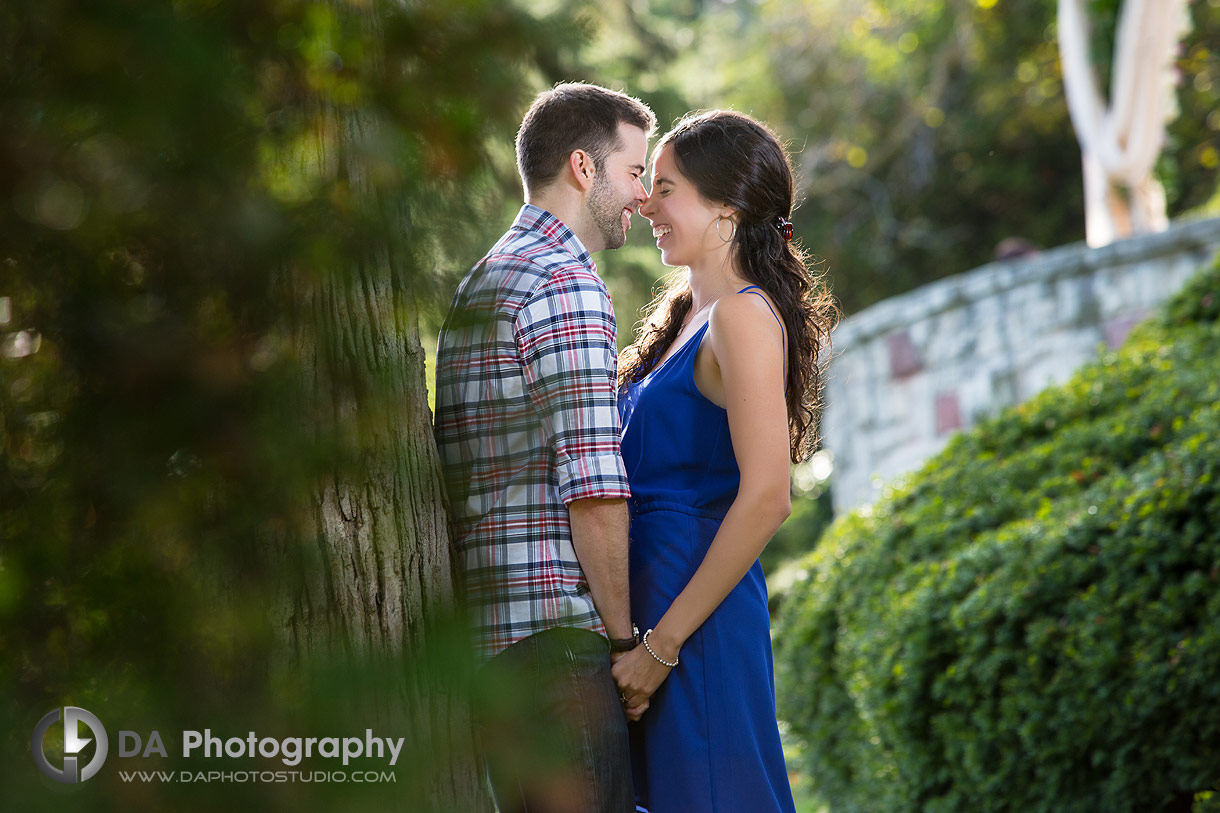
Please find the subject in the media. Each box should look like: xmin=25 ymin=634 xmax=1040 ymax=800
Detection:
xmin=619 ymin=286 xmax=794 ymax=813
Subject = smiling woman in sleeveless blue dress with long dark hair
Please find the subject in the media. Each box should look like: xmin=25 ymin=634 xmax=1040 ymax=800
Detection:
xmin=614 ymin=111 xmax=833 ymax=813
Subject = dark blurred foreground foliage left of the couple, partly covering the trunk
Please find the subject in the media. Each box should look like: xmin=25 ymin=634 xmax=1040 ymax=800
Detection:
xmin=0 ymin=0 xmax=571 ymax=809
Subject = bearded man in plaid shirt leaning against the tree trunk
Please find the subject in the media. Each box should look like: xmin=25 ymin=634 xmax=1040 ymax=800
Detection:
xmin=436 ymin=84 xmax=655 ymax=813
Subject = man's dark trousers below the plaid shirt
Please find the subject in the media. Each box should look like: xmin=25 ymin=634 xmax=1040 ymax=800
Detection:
xmin=475 ymin=627 xmax=636 ymax=813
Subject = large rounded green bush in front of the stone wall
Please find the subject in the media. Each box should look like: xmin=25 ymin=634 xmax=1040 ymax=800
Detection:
xmin=776 ymin=250 xmax=1220 ymax=813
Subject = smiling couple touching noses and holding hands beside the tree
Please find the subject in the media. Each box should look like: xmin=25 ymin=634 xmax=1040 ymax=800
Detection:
xmin=436 ymin=84 xmax=831 ymax=813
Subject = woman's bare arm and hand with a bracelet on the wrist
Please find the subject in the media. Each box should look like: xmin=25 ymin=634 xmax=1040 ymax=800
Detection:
xmin=614 ymin=294 xmax=792 ymax=706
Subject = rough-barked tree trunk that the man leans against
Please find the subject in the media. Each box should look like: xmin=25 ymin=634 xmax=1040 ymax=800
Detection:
xmin=276 ymin=2 xmax=489 ymax=812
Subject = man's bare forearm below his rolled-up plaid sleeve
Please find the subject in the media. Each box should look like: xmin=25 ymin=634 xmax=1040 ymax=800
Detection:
xmin=567 ymin=499 xmax=631 ymax=638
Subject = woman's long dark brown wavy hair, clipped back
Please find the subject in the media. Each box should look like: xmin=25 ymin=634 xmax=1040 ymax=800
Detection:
xmin=619 ymin=110 xmax=838 ymax=463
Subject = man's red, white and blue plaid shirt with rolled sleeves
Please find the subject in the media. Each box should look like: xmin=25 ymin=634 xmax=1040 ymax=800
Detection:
xmin=436 ymin=204 xmax=631 ymax=658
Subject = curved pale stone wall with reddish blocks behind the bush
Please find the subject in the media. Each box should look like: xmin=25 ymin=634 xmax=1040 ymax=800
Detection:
xmin=822 ymin=213 xmax=1220 ymax=510
